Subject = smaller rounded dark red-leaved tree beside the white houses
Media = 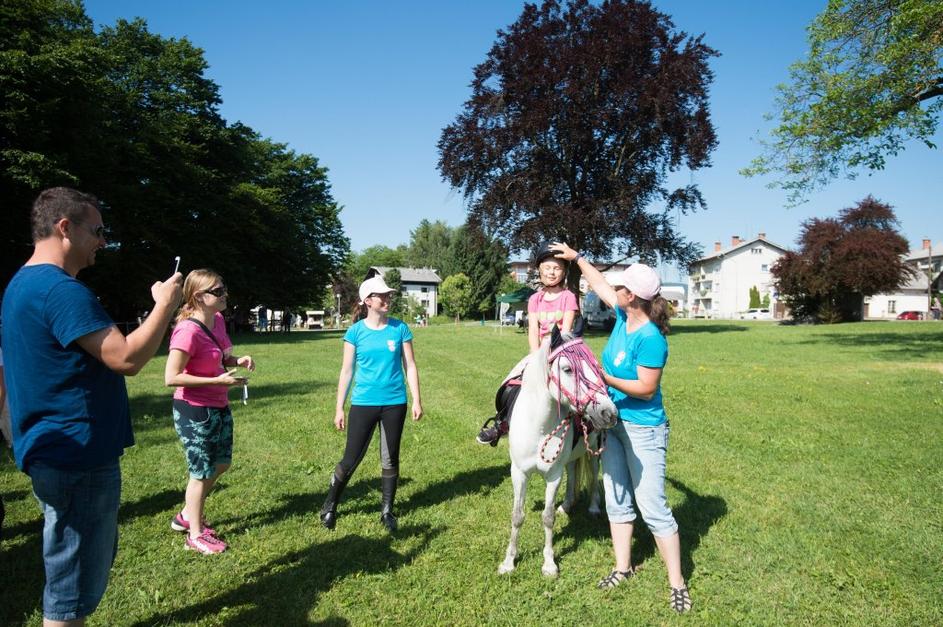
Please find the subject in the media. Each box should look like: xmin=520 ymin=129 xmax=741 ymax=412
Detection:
xmin=772 ymin=196 xmax=913 ymax=322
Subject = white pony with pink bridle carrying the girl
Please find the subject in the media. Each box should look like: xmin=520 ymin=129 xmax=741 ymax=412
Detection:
xmin=498 ymin=328 xmax=618 ymax=577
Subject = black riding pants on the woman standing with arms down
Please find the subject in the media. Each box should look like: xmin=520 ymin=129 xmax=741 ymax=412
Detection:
xmin=339 ymin=403 xmax=406 ymax=479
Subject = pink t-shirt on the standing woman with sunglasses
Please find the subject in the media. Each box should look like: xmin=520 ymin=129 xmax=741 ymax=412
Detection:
xmin=170 ymin=313 xmax=232 ymax=407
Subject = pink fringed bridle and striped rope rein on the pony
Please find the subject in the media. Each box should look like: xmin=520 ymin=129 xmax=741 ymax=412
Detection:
xmin=540 ymin=338 xmax=608 ymax=464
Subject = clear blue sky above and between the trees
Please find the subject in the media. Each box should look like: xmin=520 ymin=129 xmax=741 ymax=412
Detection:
xmin=85 ymin=0 xmax=943 ymax=274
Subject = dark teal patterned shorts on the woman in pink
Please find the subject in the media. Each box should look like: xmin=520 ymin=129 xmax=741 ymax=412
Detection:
xmin=174 ymin=398 xmax=232 ymax=479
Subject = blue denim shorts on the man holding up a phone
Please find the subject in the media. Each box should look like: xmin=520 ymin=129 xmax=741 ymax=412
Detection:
xmin=29 ymin=460 xmax=121 ymax=621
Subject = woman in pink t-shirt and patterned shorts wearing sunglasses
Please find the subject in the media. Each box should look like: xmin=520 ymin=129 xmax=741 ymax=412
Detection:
xmin=164 ymin=270 xmax=255 ymax=555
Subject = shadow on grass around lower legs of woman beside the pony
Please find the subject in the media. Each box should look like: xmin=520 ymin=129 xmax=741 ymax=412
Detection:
xmin=632 ymin=479 xmax=727 ymax=581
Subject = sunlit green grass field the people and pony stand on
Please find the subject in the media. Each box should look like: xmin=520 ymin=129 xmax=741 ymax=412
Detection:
xmin=0 ymin=321 xmax=943 ymax=625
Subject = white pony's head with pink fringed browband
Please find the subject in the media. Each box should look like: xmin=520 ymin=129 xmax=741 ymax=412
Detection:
xmin=538 ymin=325 xmax=618 ymax=429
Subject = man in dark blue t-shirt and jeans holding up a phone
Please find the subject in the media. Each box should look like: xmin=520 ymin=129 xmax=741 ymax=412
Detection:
xmin=0 ymin=187 xmax=182 ymax=625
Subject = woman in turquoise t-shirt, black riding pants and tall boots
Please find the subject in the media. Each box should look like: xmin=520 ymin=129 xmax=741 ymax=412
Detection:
xmin=321 ymin=276 xmax=422 ymax=532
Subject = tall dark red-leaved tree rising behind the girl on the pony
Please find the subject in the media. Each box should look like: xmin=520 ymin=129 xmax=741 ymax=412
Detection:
xmin=438 ymin=0 xmax=717 ymax=290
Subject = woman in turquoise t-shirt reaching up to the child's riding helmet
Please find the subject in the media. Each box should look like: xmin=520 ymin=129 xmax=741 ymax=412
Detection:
xmin=552 ymin=244 xmax=691 ymax=612
